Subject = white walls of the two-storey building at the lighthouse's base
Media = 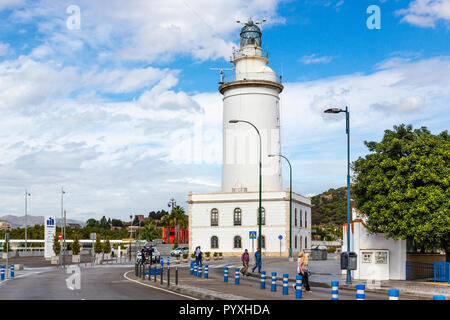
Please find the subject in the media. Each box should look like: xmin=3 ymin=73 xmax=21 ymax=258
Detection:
xmin=189 ymin=192 xmax=311 ymax=256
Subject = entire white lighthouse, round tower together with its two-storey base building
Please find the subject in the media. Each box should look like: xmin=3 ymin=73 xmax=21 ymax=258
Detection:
xmin=188 ymin=19 xmax=311 ymax=257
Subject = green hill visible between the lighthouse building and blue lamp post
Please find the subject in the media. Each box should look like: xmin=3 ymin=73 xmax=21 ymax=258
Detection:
xmin=311 ymin=187 xmax=347 ymax=226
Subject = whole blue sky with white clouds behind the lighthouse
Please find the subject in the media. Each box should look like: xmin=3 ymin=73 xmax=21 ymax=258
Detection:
xmin=0 ymin=0 xmax=450 ymax=220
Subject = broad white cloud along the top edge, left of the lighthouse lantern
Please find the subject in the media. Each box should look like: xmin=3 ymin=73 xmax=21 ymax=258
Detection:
xmin=10 ymin=0 xmax=283 ymax=63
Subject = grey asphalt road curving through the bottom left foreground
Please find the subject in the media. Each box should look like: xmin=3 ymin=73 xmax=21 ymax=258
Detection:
xmin=0 ymin=267 xmax=196 ymax=300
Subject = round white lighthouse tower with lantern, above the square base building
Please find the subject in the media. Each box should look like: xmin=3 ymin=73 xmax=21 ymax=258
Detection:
xmin=219 ymin=20 xmax=283 ymax=192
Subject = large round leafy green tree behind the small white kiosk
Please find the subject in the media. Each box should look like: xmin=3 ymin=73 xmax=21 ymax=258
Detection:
xmin=353 ymin=124 xmax=450 ymax=261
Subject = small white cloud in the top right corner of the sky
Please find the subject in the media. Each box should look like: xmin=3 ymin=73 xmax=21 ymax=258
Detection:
xmin=396 ymin=0 xmax=450 ymax=28
